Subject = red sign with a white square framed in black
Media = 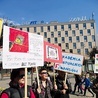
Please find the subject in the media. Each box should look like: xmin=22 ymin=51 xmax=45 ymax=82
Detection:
xmin=44 ymin=41 xmax=62 ymax=63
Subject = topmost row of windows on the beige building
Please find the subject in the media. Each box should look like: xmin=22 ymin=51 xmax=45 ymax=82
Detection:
xmin=20 ymin=23 xmax=94 ymax=32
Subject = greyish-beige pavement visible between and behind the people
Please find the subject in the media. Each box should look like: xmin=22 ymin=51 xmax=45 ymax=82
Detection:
xmin=0 ymin=73 xmax=96 ymax=98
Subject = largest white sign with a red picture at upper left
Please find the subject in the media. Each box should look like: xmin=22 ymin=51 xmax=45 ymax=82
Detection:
xmin=3 ymin=26 xmax=44 ymax=69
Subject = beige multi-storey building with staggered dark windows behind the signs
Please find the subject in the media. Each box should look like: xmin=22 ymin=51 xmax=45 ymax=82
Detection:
xmin=16 ymin=19 xmax=96 ymax=58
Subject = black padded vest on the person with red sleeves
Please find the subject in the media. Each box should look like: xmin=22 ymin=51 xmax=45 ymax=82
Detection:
xmin=0 ymin=82 xmax=35 ymax=98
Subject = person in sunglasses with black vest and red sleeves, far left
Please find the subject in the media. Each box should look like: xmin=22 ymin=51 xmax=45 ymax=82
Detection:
xmin=0 ymin=68 xmax=35 ymax=98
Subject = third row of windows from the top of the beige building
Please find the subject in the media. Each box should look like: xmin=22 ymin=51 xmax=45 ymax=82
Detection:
xmin=47 ymin=35 xmax=95 ymax=43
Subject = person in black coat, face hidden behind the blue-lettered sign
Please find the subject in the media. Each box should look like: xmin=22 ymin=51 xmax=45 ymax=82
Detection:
xmin=54 ymin=71 xmax=71 ymax=98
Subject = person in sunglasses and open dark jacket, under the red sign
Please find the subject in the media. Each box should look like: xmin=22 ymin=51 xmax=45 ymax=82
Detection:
xmin=32 ymin=67 xmax=57 ymax=98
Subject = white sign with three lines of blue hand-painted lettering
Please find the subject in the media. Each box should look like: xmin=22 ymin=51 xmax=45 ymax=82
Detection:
xmin=54 ymin=53 xmax=83 ymax=74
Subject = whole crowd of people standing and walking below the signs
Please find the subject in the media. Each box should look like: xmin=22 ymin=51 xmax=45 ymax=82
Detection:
xmin=0 ymin=67 xmax=98 ymax=98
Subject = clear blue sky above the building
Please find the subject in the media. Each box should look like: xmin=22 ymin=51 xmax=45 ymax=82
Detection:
xmin=0 ymin=0 xmax=98 ymax=32
